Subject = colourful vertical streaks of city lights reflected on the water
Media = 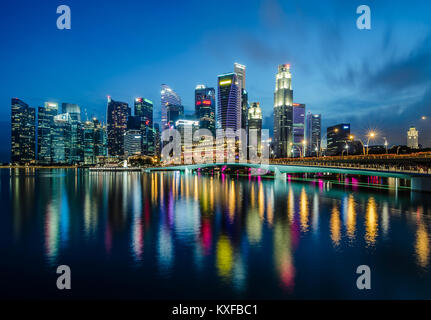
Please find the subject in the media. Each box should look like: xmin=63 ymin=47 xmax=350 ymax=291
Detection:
xmin=8 ymin=170 xmax=431 ymax=295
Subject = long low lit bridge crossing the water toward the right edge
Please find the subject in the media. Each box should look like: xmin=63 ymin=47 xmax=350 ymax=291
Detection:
xmin=146 ymin=162 xmax=431 ymax=192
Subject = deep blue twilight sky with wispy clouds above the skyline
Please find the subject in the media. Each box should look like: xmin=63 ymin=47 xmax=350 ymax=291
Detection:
xmin=0 ymin=0 xmax=431 ymax=160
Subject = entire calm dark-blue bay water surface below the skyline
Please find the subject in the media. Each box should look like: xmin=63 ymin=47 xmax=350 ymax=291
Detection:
xmin=0 ymin=169 xmax=431 ymax=299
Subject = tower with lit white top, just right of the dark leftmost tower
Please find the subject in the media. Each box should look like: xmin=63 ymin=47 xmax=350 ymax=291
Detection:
xmin=37 ymin=102 xmax=58 ymax=164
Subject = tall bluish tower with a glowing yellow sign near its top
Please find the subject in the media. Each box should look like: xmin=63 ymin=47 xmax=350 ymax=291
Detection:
xmin=217 ymin=73 xmax=241 ymax=131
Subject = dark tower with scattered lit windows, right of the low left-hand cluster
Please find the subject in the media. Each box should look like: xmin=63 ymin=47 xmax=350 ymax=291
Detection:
xmin=106 ymin=97 xmax=131 ymax=156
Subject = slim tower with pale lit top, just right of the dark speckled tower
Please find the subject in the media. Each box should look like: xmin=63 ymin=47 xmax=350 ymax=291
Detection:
xmin=135 ymin=98 xmax=154 ymax=156
